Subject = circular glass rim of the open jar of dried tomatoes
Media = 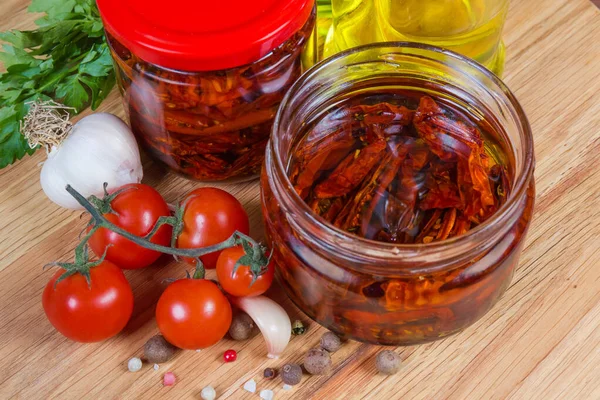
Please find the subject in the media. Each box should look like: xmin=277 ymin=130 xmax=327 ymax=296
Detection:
xmin=267 ymin=42 xmax=535 ymax=262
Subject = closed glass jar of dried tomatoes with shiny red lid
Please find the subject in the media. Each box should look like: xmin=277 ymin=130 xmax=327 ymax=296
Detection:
xmin=97 ymin=0 xmax=316 ymax=181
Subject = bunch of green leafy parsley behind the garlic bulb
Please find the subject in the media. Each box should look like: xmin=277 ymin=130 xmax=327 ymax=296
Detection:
xmin=0 ymin=0 xmax=115 ymax=168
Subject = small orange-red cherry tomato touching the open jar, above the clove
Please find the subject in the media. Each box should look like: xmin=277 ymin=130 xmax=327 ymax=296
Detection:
xmin=217 ymin=246 xmax=275 ymax=297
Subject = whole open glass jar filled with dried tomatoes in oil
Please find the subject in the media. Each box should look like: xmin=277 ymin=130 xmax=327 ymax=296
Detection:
xmin=261 ymin=43 xmax=535 ymax=346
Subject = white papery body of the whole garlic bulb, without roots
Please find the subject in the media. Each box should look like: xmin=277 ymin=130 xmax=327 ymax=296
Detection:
xmin=40 ymin=113 xmax=143 ymax=210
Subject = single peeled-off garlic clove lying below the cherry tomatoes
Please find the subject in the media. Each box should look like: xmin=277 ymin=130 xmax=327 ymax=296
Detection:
xmin=232 ymin=296 xmax=292 ymax=359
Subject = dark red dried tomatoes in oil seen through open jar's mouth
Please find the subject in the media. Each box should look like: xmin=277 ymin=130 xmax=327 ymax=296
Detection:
xmin=289 ymin=91 xmax=510 ymax=244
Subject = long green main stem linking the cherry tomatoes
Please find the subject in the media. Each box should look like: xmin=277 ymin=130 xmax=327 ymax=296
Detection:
xmin=66 ymin=185 xmax=260 ymax=258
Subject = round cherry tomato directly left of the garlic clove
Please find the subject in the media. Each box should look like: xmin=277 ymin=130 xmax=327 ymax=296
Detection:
xmin=156 ymin=279 xmax=231 ymax=350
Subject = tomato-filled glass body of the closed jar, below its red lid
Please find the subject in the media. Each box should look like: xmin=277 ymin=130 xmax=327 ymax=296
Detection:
xmin=107 ymin=11 xmax=316 ymax=181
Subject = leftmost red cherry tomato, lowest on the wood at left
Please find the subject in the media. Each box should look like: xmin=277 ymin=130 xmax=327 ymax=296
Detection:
xmin=42 ymin=261 xmax=133 ymax=343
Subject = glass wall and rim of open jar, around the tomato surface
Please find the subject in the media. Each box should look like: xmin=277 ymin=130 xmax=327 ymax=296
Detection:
xmin=261 ymin=42 xmax=535 ymax=345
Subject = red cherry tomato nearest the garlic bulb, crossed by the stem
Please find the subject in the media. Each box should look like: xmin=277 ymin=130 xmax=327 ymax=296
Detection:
xmin=88 ymin=183 xmax=172 ymax=269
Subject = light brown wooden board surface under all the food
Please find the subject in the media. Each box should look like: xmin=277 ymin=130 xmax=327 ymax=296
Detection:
xmin=0 ymin=0 xmax=600 ymax=400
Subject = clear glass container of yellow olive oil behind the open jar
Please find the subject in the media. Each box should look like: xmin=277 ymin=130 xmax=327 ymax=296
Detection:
xmin=324 ymin=0 xmax=508 ymax=76
